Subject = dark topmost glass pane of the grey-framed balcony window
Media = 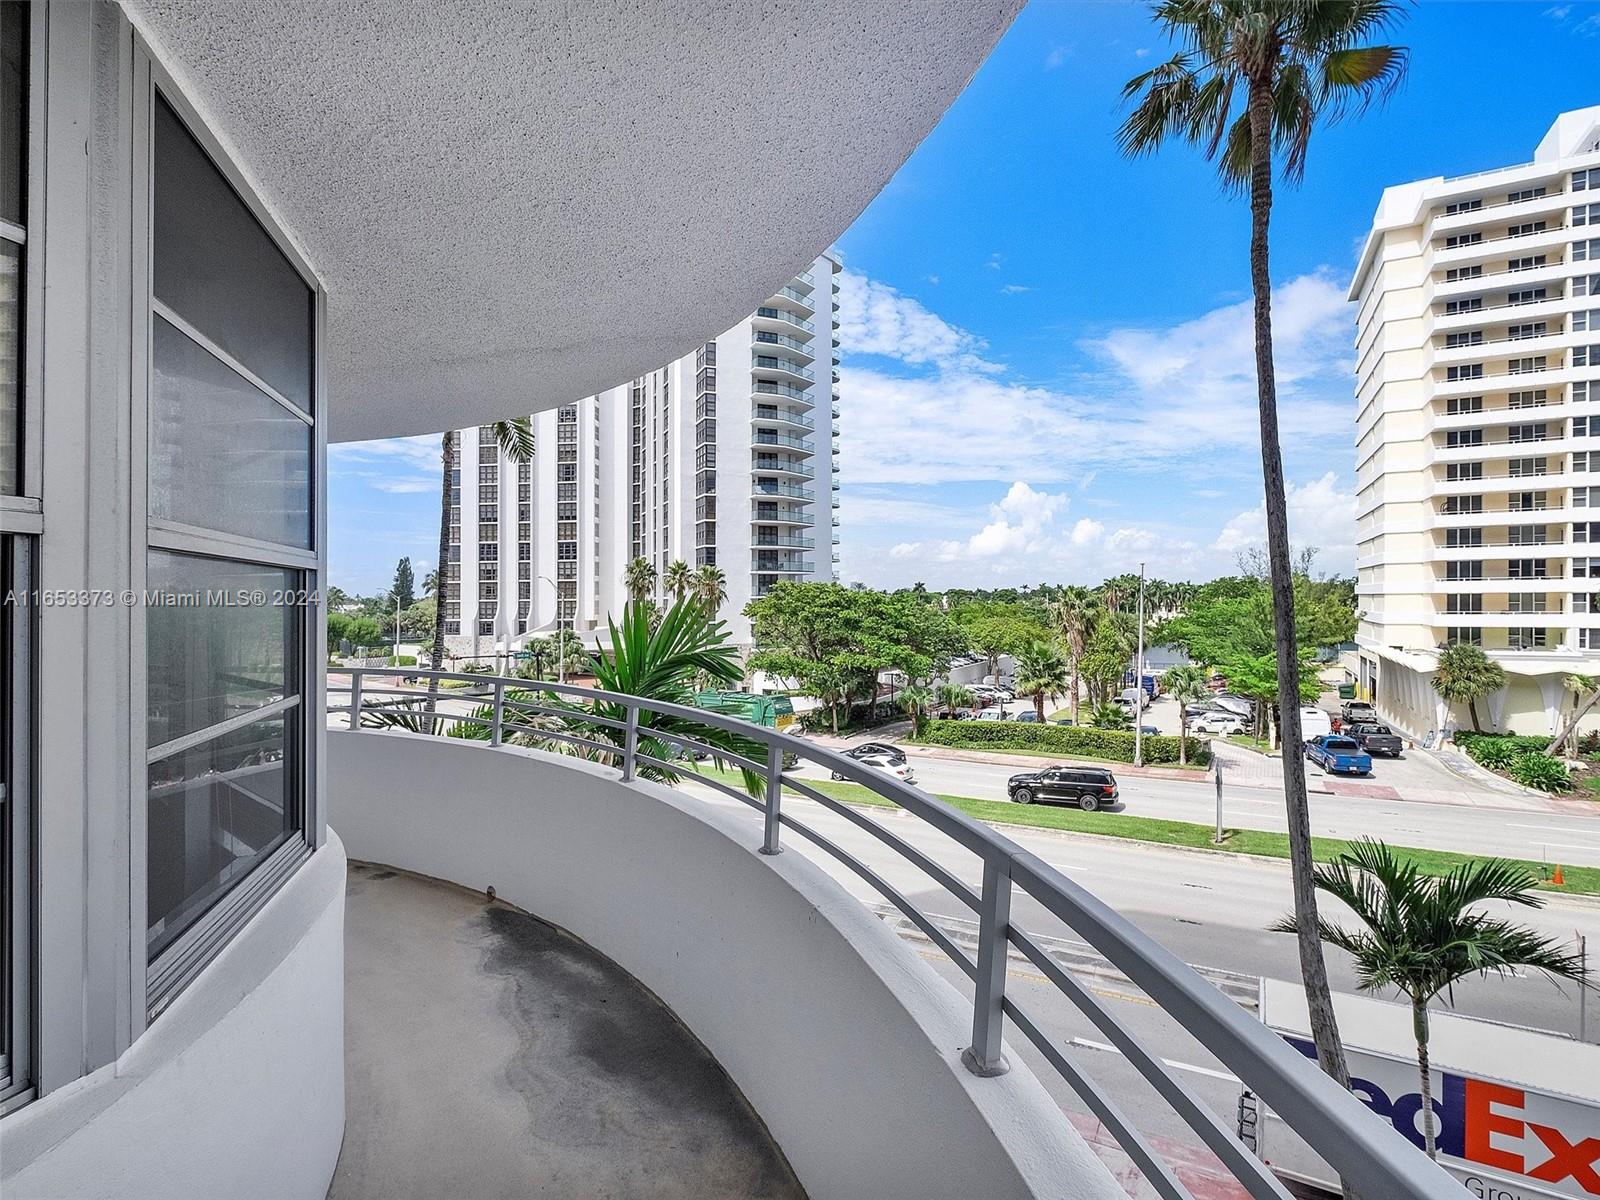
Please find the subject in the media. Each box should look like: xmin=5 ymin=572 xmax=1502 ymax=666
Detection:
xmin=155 ymin=99 xmax=312 ymax=411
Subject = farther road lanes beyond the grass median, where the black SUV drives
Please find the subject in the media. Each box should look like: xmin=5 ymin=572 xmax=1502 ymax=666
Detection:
xmin=800 ymin=747 xmax=1600 ymax=866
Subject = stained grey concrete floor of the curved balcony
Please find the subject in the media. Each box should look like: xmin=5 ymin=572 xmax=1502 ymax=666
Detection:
xmin=328 ymin=862 xmax=805 ymax=1200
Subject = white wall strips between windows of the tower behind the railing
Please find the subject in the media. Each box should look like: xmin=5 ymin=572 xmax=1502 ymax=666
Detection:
xmin=446 ymin=251 xmax=842 ymax=658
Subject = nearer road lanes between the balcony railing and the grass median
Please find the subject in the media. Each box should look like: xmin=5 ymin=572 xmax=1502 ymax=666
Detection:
xmin=691 ymin=781 xmax=1600 ymax=1195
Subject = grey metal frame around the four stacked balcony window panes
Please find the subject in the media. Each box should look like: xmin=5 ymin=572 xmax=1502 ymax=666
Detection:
xmin=128 ymin=47 xmax=328 ymax=1038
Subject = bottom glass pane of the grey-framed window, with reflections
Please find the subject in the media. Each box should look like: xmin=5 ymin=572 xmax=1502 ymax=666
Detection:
xmin=147 ymin=710 xmax=301 ymax=958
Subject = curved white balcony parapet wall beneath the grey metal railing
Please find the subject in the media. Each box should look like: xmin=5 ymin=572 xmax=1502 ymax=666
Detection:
xmin=328 ymin=731 xmax=1123 ymax=1200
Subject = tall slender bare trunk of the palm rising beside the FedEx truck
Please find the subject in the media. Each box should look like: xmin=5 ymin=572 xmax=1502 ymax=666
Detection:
xmin=1250 ymin=78 xmax=1350 ymax=1107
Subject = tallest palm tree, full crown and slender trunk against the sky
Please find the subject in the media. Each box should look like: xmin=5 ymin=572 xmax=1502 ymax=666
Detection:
xmin=1118 ymin=0 xmax=1406 ymax=1107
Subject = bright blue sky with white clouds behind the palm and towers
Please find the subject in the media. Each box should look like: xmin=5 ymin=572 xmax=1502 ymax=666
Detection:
xmin=330 ymin=0 xmax=1600 ymax=592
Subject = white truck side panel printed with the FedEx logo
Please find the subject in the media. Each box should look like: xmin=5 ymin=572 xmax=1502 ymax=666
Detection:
xmin=1283 ymin=1034 xmax=1600 ymax=1200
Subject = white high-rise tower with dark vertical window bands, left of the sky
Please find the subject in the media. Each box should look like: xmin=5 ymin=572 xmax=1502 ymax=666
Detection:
xmin=443 ymin=250 xmax=843 ymax=656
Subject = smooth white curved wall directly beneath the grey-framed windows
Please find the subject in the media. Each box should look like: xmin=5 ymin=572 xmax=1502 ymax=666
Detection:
xmin=0 ymin=834 xmax=344 ymax=1200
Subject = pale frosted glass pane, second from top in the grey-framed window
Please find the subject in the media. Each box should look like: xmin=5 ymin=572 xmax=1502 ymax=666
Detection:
xmin=150 ymin=317 xmax=312 ymax=547
